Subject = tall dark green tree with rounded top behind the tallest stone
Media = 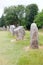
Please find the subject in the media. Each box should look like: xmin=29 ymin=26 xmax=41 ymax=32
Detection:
xmin=25 ymin=4 xmax=38 ymax=29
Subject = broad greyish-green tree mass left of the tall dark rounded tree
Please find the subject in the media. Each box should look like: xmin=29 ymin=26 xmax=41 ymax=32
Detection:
xmin=4 ymin=5 xmax=24 ymax=26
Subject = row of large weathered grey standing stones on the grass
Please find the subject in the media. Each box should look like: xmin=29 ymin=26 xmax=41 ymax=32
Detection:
xmin=7 ymin=23 xmax=39 ymax=49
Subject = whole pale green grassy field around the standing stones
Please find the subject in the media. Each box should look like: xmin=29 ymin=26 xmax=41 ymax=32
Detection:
xmin=0 ymin=30 xmax=43 ymax=65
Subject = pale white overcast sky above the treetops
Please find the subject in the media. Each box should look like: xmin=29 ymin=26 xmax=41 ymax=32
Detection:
xmin=0 ymin=0 xmax=43 ymax=17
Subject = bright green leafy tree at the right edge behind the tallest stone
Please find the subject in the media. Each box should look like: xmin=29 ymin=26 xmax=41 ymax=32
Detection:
xmin=34 ymin=11 xmax=43 ymax=28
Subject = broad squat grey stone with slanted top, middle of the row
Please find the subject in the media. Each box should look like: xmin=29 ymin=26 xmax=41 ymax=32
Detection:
xmin=14 ymin=26 xmax=25 ymax=40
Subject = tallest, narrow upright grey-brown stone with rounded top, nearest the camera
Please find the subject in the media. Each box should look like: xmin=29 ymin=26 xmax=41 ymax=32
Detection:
xmin=30 ymin=23 xmax=38 ymax=49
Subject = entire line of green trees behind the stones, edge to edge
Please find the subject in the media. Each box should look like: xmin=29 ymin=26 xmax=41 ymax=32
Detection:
xmin=0 ymin=4 xmax=43 ymax=29
